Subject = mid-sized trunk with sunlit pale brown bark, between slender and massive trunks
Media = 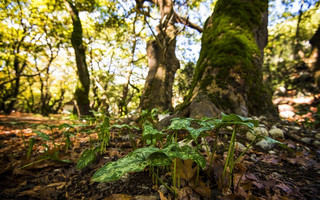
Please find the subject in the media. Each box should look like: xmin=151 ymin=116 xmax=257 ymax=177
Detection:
xmin=140 ymin=0 xmax=180 ymax=111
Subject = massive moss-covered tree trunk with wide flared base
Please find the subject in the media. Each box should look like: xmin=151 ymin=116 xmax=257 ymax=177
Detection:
xmin=177 ymin=0 xmax=279 ymax=119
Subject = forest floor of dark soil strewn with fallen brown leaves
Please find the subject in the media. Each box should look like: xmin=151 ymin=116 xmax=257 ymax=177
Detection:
xmin=0 ymin=108 xmax=320 ymax=200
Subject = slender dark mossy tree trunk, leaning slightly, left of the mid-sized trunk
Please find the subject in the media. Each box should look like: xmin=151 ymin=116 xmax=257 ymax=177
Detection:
xmin=65 ymin=0 xmax=90 ymax=116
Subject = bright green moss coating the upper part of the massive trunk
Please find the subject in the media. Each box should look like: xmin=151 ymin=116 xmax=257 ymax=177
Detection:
xmin=187 ymin=0 xmax=268 ymax=95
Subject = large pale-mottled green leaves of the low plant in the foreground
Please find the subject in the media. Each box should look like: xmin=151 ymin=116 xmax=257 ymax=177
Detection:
xmin=92 ymin=114 xmax=258 ymax=188
